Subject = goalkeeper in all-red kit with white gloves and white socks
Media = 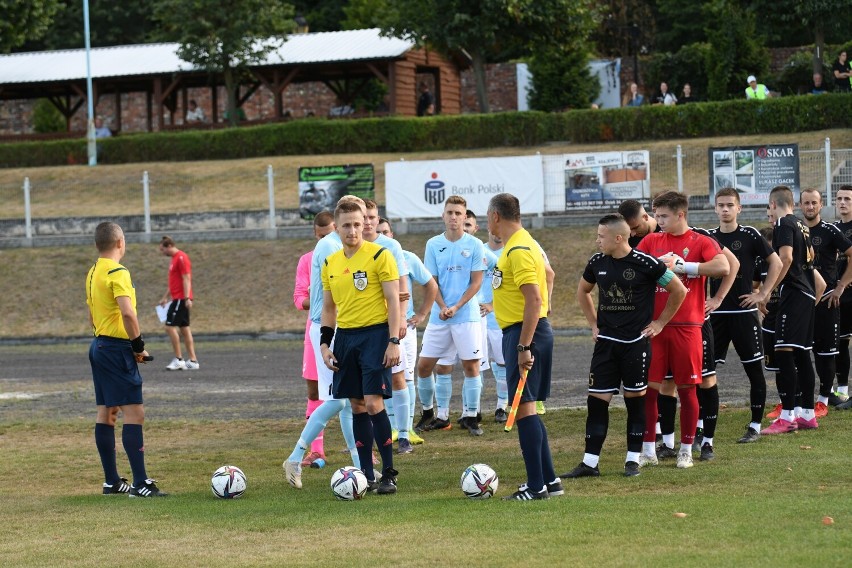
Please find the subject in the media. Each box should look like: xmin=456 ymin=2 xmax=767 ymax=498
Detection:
xmin=636 ymin=191 xmax=730 ymax=469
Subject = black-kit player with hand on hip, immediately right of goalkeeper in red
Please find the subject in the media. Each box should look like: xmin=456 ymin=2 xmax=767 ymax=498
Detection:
xmin=710 ymin=187 xmax=781 ymax=444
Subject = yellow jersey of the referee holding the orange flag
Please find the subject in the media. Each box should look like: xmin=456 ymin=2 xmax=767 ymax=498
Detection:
xmin=491 ymin=229 xmax=548 ymax=328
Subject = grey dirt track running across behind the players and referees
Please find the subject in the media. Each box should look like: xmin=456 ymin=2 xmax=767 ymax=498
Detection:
xmin=0 ymin=337 xmax=752 ymax=424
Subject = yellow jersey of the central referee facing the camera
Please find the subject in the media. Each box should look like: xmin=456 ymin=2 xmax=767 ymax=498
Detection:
xmin=322 ymin=241 xmax=399 ymax=329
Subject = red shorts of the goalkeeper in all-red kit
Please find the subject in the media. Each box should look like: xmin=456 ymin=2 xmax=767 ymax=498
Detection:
xmin=648 ymin=325 xmax=704 ymax=385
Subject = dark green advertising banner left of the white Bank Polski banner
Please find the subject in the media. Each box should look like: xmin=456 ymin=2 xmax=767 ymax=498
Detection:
xmin=299 ymin=164 xmax=376 ymax=219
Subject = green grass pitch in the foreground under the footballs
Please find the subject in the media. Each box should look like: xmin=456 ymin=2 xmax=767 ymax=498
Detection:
xmin=0 ymin=409 xmax=852 ymax=567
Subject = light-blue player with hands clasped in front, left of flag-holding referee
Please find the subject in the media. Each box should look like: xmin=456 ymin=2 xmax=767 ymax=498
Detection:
xmin=415 ymin=195 xmax=485 ymax=436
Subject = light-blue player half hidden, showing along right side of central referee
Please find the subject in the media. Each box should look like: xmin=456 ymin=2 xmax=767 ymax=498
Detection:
xmin=363 ymin=199 xmax=414 ymax=454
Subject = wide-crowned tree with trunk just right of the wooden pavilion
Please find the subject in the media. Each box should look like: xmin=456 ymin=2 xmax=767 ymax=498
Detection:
xmin=381 ymin=0 xmax=596 ymax=112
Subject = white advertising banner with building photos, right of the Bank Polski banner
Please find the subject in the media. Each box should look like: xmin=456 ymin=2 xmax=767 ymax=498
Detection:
xmin=563 ymin=150 xmax=651 ymax=208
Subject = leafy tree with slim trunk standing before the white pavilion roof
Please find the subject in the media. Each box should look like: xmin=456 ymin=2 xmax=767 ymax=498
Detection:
xmin=155 ymin=0 xmax=295 ymax=126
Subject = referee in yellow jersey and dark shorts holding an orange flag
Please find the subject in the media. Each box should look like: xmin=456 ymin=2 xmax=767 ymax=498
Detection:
xmin=488 ymin=193 xmax=564 ymax=501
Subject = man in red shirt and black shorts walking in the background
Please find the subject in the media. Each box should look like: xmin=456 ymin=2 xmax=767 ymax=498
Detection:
xmin=160 ymin=236 xmax=198 ymax=371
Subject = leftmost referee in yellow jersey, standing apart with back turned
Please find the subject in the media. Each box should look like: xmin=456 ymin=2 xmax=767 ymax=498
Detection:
xmin=86 ymin=222 xmax=167 ymax=497
